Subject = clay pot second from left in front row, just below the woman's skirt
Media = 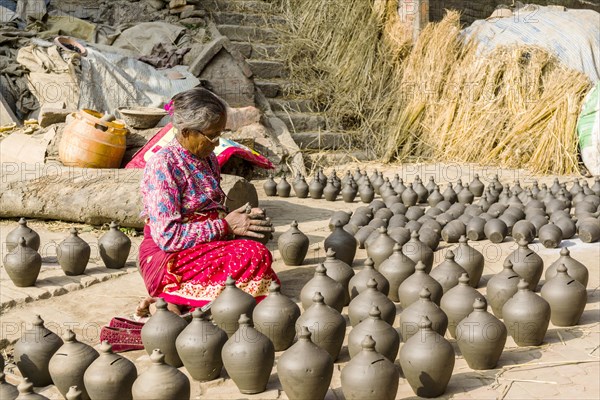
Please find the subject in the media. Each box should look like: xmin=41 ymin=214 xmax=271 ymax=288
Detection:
xmin=175 ymin=310 xmax=230 ymax=382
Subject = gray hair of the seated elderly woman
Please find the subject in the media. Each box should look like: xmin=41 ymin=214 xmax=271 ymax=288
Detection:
xmin=171 ymin=88 xmax=227 ymax=133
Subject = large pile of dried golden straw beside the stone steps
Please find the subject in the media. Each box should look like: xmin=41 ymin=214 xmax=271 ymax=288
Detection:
xmin=283 ymin=0 xmax=591 ymax=174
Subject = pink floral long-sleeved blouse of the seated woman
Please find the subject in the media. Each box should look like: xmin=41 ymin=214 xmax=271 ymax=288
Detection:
xmin=141 ymin=139 xmax=228 ymax=252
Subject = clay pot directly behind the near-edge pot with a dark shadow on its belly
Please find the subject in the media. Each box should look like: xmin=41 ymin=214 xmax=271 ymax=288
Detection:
xmin=400 ymin=288 xmax=448 ymax=342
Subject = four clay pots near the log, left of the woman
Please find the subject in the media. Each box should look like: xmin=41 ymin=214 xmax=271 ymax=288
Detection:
xmin=4 ymin=218 xmax=131 ymax=287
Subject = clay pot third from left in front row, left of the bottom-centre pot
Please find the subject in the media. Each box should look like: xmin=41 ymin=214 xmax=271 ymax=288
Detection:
xmin=221 ymin=314 xmax=275 ymax=394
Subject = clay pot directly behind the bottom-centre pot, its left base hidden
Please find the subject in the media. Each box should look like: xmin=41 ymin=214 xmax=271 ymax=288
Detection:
xmin=296 ymin=292 xmax=346 ymax=360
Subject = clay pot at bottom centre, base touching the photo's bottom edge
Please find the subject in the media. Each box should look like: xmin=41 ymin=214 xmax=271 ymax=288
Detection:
xmin=277 ymin=326 xmax=333 ymax=400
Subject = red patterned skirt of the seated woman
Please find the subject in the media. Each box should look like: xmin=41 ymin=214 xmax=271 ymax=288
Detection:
xmin=139 ymin=214 xmax=279 ymax=308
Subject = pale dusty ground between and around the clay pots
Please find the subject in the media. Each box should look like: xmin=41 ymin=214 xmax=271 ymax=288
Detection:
xmin=0 ymin=164 xmax=600 ymax=399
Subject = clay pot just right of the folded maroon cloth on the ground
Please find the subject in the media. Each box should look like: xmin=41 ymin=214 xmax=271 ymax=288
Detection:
xmin=141 ymin=298 xmax=187 ymax=368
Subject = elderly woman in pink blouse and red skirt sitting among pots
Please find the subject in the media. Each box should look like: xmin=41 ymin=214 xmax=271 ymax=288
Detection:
xmin=137 ymin=88 xmax=278 ymax=316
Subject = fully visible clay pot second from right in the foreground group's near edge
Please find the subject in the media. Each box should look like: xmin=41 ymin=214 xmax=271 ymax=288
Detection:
xmin=502 ymin=279 xmax=550 ymax=346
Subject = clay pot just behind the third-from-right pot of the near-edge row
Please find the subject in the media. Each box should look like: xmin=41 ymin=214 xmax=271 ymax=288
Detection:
xmin=438 ymin=273 xmax=481 ymax=339
